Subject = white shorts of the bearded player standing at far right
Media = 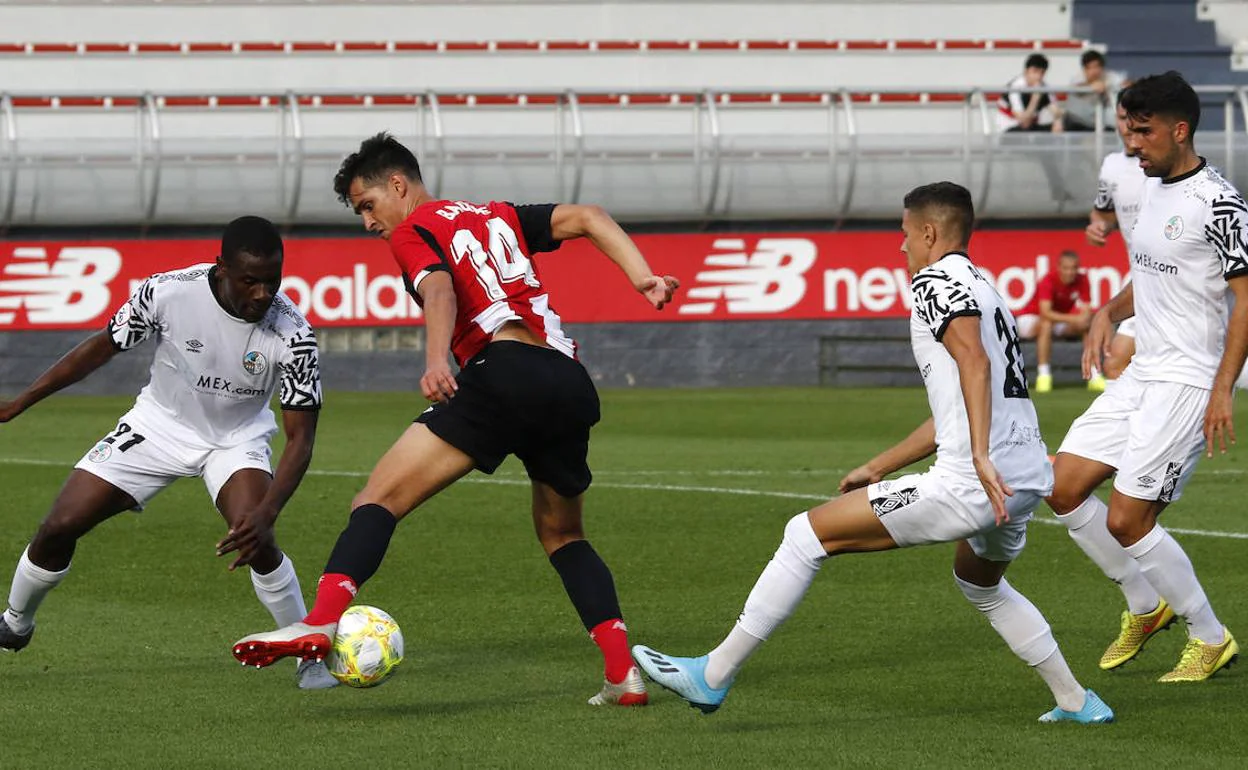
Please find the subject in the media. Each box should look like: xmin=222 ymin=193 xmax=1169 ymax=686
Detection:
xmin=1057 ymin=367 xmax=1209 ymax=503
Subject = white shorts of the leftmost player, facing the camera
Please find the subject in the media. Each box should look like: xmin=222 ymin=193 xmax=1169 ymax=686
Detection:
xmin=74 ymin=407 xmax=273 ymax=510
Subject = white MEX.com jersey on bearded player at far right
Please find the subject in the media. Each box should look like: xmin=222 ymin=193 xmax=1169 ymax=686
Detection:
xmin=1131 ymin=161 xmax=1248 ymax=389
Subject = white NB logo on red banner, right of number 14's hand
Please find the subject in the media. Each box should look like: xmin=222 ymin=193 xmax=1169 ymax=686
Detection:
xmin=679 ymin=238 xmax=816 ymax=316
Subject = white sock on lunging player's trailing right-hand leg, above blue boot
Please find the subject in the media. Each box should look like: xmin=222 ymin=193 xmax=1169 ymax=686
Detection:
xmin=953 ymin=574 xmax=1087 ymax=711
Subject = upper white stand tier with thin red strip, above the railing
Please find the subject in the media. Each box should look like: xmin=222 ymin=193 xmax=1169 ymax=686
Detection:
xmin=0 ymin=37 xmax=1087 ymax=92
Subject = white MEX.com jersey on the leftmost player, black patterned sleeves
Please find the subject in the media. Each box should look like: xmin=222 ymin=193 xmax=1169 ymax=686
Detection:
xmin=109 ymin=265 xmax=321 ymax=447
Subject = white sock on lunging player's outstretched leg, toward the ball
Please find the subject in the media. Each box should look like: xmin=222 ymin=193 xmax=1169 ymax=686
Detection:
xmin=706 ymin=512 xmax=827 ymax=689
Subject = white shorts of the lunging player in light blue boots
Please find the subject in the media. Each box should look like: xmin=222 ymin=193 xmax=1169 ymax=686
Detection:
xmin=866 ymin=470 xmax=1045 ymax=562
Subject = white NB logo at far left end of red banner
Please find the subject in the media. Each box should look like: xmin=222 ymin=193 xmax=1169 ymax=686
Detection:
xmin=0 ymin=246 xmax=121 ymax=326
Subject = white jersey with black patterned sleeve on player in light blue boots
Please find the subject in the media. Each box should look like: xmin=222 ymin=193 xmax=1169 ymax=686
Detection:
xmin=910 ymin=253 xmax=1053 ymax=493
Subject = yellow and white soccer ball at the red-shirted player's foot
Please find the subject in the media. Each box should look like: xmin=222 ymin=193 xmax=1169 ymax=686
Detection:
xmin=326 ymin=604 xmax=403 ymax=688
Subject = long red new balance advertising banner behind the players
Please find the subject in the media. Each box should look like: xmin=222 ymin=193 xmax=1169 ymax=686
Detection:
xmin=0 ymin=231 xmax=1127 ymax=331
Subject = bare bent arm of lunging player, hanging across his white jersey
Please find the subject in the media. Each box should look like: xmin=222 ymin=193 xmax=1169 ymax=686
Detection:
xmin=941 ymin=314 xmax=1013 ymax=524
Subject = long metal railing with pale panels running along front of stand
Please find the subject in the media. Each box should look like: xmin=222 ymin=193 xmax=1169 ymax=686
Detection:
xmin=0 ymin=86 xmax=1248 ymax=230
